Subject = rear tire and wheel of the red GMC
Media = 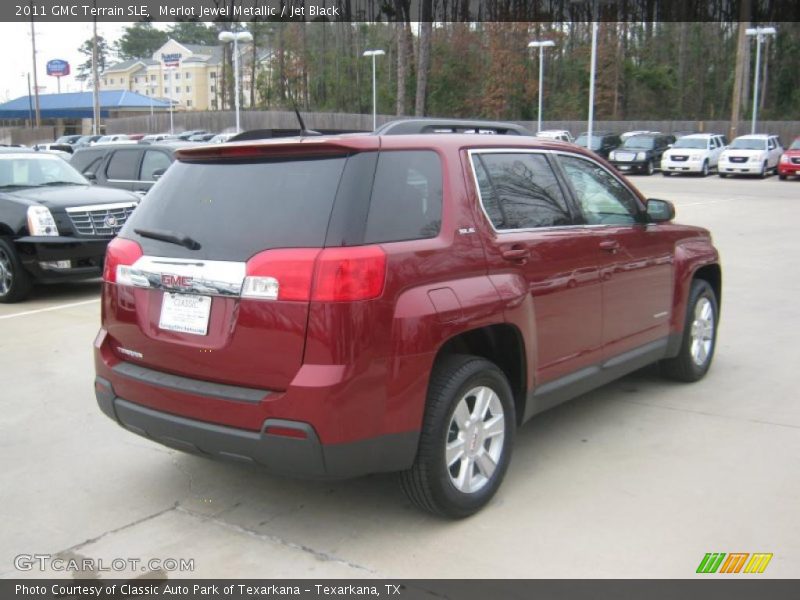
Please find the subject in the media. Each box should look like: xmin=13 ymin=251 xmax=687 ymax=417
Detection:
xmin=401 ymin=355 xmax=516 ymax=518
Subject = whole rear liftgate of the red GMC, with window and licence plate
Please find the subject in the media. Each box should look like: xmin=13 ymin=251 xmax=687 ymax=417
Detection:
xmin=105 ymin=156 xmax=347 ymax=390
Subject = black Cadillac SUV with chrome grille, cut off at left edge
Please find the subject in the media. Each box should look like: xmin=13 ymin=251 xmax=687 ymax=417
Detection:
xmin=0 ymin=149 xmax=138 ymax=303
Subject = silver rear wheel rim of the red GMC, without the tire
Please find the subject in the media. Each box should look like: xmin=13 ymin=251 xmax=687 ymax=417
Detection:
xmin=445 ymin=386 xmax=505 ymax=494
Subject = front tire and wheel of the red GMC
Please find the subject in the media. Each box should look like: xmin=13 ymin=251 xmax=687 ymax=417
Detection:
xmin=661 ymin=279 xmax=719 ymax=382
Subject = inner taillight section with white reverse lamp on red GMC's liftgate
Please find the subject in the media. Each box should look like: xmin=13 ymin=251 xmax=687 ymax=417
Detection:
xmin=242 ymin=248 xmax=320 ymax=302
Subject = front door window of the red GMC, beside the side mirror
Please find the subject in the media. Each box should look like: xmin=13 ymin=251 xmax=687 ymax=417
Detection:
xmin=559 ymin=156 xmax=639 ymax=225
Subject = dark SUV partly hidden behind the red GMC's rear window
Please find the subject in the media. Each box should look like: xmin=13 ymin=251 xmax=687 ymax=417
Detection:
xmin=70 ymin=142 xmax=185 ymax=194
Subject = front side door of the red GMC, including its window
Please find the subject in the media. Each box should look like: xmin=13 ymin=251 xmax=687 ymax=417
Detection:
xmin=559 ymin=155 xmax=673 ymax=358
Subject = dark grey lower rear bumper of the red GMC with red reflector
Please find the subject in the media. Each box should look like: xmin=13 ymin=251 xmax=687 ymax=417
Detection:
xmin=95 ymin=377 xmax=419 ymax=479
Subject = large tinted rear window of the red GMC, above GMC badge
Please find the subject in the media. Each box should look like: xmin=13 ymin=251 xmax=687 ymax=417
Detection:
xmin=122 ymin=156 xmax=346 ymax=262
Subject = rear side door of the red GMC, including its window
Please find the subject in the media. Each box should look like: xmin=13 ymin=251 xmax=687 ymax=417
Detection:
xmin=470 ymin=149 xmax=602 ymax=383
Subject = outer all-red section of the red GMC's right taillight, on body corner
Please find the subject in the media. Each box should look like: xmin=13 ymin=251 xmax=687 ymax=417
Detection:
xmin=311 ymin=246 xmax=386 ymax=302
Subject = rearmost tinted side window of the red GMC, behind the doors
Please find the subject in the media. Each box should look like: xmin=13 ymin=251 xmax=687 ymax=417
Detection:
xmin=364 ymin=150 xmax=442 ymax=244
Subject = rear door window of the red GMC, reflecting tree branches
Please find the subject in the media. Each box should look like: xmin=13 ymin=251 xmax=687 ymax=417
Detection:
xmin=472 ymin=153 xmax=573 ymax=230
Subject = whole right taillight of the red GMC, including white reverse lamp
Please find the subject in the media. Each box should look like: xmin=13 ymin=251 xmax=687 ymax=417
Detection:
xmin=242 ymin=246 xmax=386 ymax=302
